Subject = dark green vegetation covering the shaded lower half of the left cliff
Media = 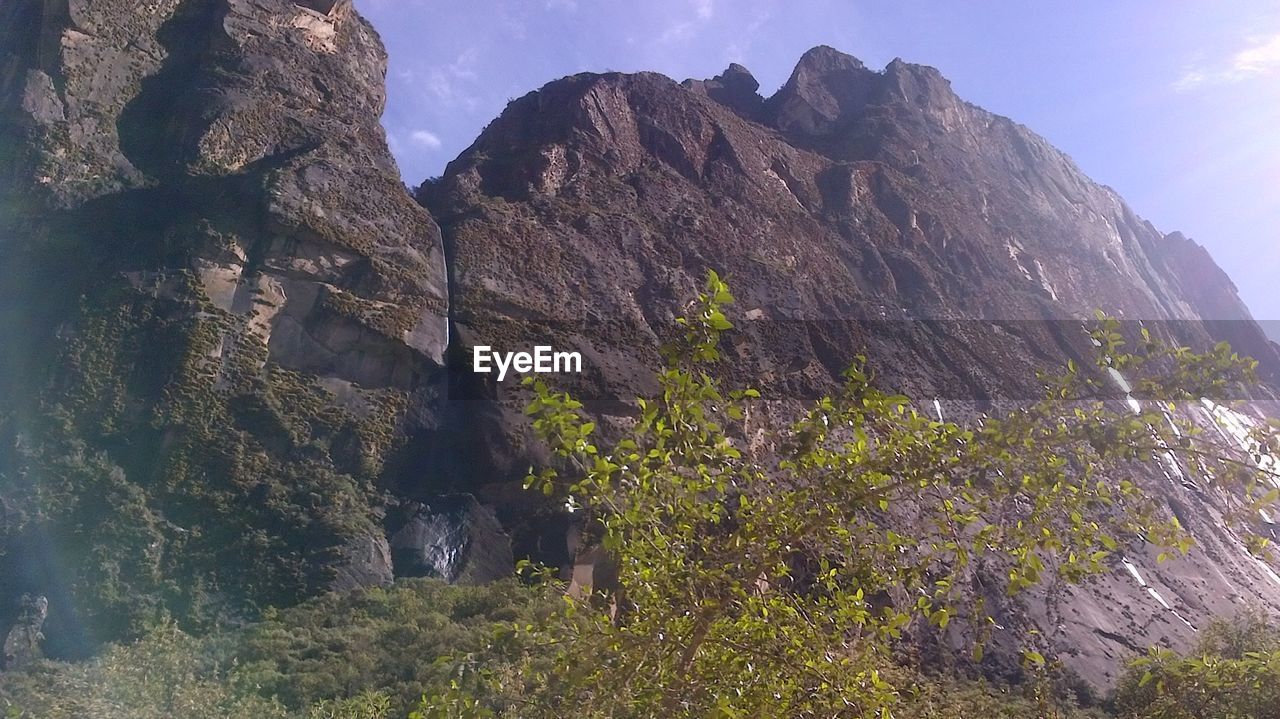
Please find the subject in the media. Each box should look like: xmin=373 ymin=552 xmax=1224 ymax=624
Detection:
xmin=0 ymin=277 xmax=404 ymax=639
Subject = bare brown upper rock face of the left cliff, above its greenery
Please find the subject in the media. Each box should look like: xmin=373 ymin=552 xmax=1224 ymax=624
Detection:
xmin=6 ymin=0 xmax=447 ymax=376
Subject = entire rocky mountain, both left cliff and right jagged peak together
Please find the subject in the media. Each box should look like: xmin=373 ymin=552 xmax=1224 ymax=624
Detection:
xmin=0 ymin=0 xmax=1280 ymax=683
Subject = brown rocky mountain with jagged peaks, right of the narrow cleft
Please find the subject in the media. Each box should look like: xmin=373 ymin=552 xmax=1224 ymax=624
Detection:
xmin=419 ymin=47 xmax=1280 ymax=684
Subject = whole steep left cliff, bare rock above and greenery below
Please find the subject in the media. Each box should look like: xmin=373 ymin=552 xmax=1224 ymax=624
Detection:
xmin=0 ymin=0 xmax=447 ymax=652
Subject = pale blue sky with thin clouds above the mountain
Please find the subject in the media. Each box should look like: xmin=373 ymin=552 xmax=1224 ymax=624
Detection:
xmin=356 ymin=0 xmax=1280 ymax=330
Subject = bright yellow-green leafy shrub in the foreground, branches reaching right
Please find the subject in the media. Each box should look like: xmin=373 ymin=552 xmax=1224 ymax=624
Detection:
xmin=414 ymin=274 xmax=1280 ymax=718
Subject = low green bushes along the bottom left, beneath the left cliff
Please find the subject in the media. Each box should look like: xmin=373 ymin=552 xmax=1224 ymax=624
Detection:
xmin=0 ymin=580 xmax=550 ymax=719
